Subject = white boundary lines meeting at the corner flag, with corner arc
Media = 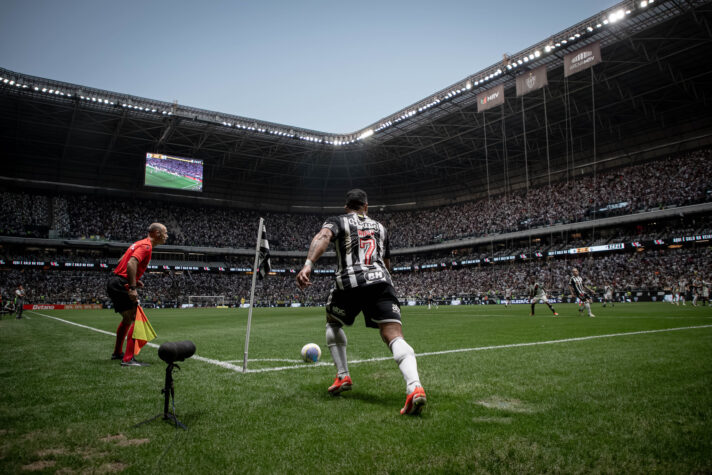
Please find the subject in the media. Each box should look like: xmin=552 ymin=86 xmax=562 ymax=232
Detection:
xmin=28 ymin=310 xmax=712 ymax=373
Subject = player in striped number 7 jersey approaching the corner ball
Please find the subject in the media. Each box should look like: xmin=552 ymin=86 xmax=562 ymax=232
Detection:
xmin=297 ymin=189 xmax=426 ymax=415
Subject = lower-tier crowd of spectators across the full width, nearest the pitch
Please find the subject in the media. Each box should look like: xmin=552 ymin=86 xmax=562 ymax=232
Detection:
xmin=0 ymin=247 xmax=712 ymax=305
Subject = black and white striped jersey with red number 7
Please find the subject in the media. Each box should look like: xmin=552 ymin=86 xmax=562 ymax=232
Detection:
xmin=322 ymin=213 xmax=393 ymax=289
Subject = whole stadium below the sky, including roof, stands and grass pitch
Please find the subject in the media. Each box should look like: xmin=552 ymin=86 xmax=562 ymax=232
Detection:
xmin=0 ymin=0 xmax=712 ymax=473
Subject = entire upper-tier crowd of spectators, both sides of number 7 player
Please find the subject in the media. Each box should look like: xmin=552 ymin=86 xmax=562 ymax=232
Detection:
xmin=0 ymin=149 xmax=712 ymax=251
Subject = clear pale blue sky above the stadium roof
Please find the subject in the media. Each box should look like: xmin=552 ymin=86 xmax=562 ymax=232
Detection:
xmin=0 ymin=0 xmax=618 ymax=133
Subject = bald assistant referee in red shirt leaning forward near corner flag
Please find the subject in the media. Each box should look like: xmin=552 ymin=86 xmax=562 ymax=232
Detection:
xmin=106 ymin=223 xmax=168 ymax=366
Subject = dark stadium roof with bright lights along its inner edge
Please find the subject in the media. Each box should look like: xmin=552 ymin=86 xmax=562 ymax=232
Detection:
xmin=0 ymin=0 xmax=712 ymax=209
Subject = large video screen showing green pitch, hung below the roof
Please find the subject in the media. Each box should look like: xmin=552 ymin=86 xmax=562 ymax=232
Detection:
xmin=144 ymin=153 xmax=203 ymax=191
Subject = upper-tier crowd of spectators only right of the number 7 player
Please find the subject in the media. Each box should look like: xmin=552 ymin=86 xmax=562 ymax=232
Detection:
xmin=376 ymin=150 xmax=712 ymax=247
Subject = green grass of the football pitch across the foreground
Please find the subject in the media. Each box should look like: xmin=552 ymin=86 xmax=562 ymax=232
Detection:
xmin=0 ymin=303 xmax=712 ymax=473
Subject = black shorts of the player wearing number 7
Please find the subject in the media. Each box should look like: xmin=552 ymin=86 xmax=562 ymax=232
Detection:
xmin=326 ymin=282 xmax=401 ymax=328
